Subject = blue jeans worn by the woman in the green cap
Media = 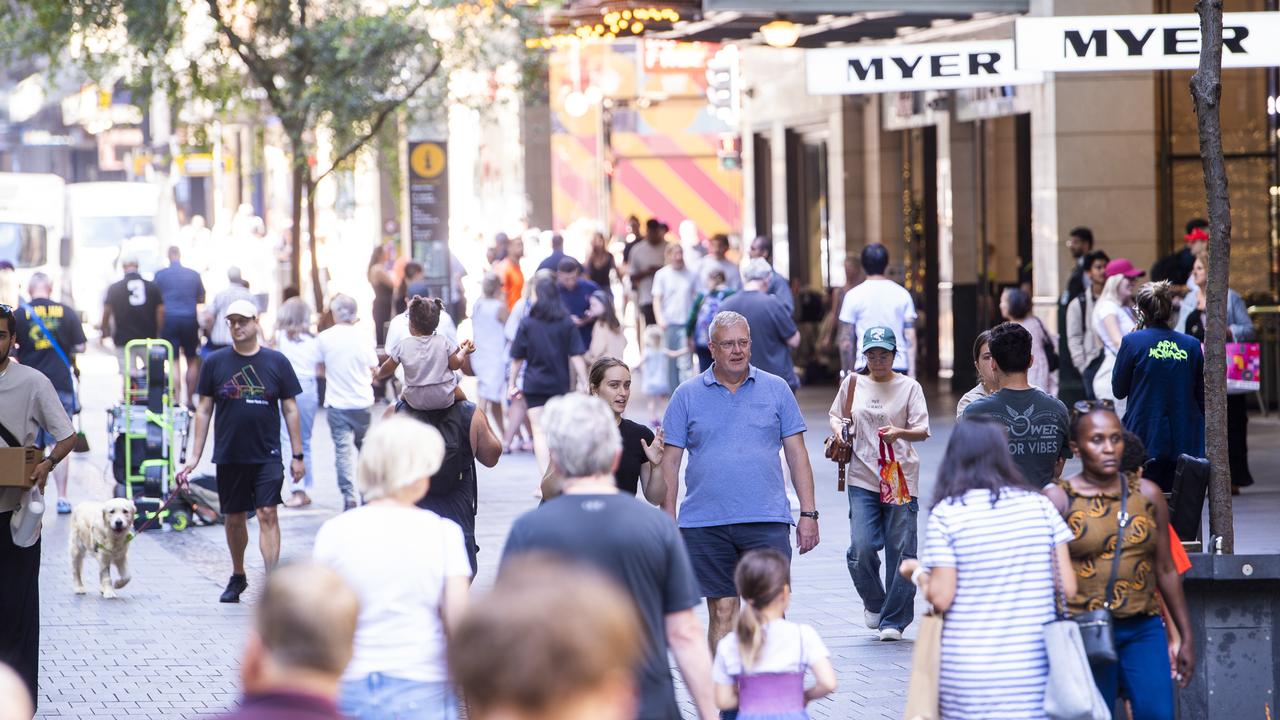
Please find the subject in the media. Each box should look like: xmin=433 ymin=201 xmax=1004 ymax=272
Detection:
xmin=845 ymin=486 xmax=920 ymax=630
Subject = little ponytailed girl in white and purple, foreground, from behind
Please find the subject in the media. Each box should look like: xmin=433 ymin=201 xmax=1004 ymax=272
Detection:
xmin=712 ymin=548 xmax=836 ymax=720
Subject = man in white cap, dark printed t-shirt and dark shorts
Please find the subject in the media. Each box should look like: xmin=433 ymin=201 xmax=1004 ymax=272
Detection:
xmin=178 ymin=300 xmax=306 ymax=602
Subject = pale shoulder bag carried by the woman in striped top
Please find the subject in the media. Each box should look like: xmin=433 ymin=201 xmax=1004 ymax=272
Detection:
xmin=1043 ymin=504 xmax=1111 ymax=720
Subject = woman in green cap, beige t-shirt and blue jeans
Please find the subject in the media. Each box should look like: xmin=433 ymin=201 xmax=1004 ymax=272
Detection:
xmin=831 ymin=327 xmax=929 ymax=641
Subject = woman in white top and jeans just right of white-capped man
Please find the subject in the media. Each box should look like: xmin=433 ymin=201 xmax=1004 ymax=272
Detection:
xmin=275 ymin=297 xmax=320 ymax=507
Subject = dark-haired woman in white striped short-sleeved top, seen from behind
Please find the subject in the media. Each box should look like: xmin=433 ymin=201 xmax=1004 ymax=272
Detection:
xmin=900 ymin=416 xmax=1075 ymax=720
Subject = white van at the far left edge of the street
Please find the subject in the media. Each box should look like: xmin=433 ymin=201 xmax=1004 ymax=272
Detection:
xmin=0 ymin=173 xmax=67 ymax=297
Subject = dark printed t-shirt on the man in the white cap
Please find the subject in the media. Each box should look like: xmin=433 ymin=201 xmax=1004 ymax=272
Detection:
xmin=197 ymin=347 xmax=302 ymax=464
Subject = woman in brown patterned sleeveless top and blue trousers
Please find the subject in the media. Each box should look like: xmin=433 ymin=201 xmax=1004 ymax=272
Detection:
xmin=1044 ymin=401 xmax=1196 ymax=720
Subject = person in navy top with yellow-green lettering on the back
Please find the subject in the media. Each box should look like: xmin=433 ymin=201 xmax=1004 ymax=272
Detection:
xmin=1111 ymin=281 xmax=1204 ymax=492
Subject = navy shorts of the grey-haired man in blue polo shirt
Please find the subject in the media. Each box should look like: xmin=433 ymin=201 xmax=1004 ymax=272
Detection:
xmin=680 ymin=523 xmax=791 ymax=597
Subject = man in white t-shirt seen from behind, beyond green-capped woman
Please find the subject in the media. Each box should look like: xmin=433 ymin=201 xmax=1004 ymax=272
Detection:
xmin=840 ymin=242 xmax=915 ymax=378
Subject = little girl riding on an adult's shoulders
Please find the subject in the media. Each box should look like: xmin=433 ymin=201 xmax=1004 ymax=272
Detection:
xmin=378 ymin=296 xmax=476 ymax=410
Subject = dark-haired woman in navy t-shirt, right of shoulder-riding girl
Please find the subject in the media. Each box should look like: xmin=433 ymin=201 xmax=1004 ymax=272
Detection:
xmin=507 ymin=277 xmax=586 ymax=473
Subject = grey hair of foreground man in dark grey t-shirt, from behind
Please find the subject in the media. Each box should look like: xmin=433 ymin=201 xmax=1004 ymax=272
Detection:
xmin=541 ymin=393 xmax=622 ymax=478
